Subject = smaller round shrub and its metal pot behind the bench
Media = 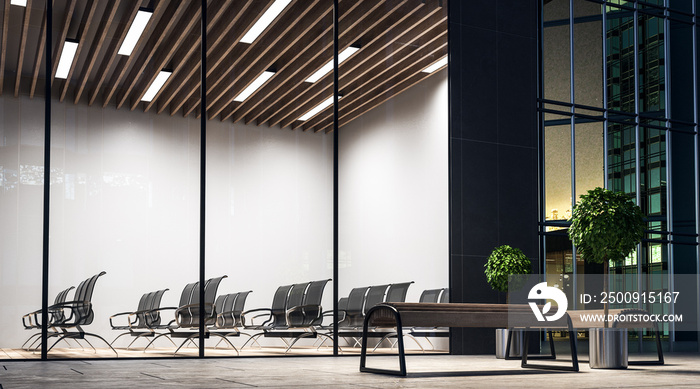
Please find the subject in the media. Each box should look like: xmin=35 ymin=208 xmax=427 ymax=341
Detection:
xmin=484 ymin=245 xmax=532 ymax=358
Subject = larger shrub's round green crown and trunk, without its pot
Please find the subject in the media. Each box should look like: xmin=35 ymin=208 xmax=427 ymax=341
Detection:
xmin=569 ymin=188 xmax=645 ymax=327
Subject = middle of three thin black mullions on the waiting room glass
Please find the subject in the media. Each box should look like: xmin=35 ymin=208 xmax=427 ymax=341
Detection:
xmin=199 ymin=0 xmax=207 ymax=358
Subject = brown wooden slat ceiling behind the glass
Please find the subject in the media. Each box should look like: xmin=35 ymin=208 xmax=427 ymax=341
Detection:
xmin=0 ymin=0 xmax=447 ymax=132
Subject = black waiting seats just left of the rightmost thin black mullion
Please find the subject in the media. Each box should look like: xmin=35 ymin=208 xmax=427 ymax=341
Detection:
xmin=242 ymin=279 xmax=330 ymax=352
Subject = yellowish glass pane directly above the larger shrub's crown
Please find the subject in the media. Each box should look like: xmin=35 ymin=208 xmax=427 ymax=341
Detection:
xmin=567 ymin=119 xmax=605 ymax=200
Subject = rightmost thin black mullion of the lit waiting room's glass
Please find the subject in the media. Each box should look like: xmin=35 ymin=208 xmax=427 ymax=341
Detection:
xmin=333 ymin=0 xmax=340 ymax=356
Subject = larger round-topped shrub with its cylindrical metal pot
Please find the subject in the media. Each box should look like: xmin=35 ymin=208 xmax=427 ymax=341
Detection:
xmin=569 ymin=188 xmax=645 ymax=368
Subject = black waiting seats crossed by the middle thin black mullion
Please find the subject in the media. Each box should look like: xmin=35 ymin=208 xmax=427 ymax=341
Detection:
xmin=144 ymin=276 xmax=228 ymax=354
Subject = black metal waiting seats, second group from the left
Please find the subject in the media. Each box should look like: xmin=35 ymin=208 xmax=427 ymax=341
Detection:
xmin=109 ymin=289 xmax=175 ymax=350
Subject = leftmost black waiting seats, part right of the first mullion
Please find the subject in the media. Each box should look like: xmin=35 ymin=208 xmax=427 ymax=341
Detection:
xmin=46 ymin=272 xmax=119 ymax=356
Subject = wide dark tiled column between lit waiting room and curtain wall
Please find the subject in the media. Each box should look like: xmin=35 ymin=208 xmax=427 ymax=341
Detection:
xmin=448 ymin=0 xmax=538 ymax=354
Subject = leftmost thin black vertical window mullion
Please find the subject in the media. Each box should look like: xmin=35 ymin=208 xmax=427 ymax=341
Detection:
xmin=41 ymin=0 xmax=53 ymax=360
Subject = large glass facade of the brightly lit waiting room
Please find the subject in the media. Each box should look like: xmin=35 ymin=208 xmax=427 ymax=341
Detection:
xmin=0 ymin=0 xmax=448 ymax=359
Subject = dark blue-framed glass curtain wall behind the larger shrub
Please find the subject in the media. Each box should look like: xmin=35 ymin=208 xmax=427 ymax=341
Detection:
xmin=539 ymin=0 xmax=698 ymax=344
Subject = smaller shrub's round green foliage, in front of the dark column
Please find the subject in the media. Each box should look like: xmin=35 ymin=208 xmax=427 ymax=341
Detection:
xmin=484 ymin=245 xmax=532 ymax=292
